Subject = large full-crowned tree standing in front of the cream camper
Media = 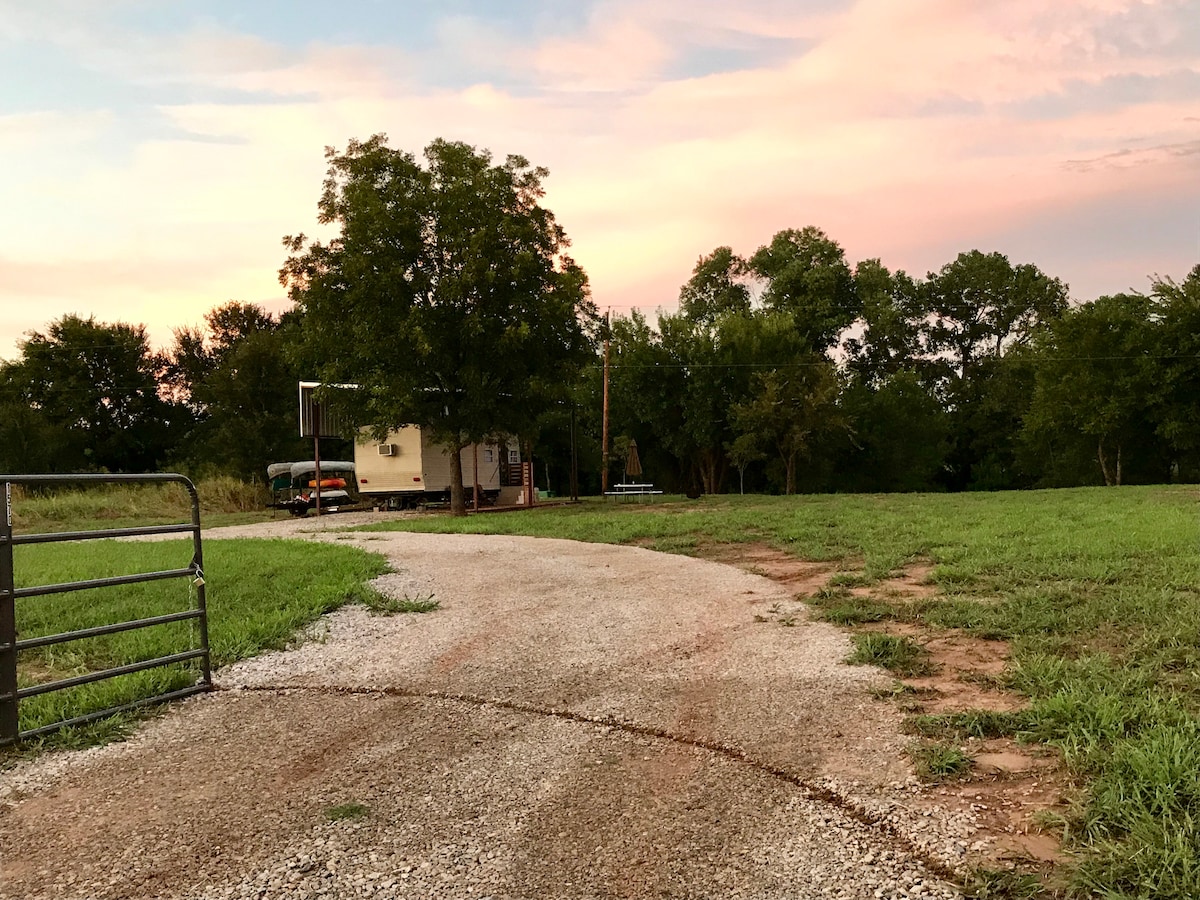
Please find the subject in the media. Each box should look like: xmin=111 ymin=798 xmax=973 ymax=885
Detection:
xmin=280 ymin=134 xmax=595 ymax=515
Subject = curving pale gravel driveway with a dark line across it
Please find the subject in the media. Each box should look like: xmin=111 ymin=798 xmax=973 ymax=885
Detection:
xmin=0 ymin=517 xmax=972 ymax=900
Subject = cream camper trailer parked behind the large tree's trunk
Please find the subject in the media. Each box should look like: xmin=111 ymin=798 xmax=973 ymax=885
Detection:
xmin=354 ymin=425 xmax=521 ymax=509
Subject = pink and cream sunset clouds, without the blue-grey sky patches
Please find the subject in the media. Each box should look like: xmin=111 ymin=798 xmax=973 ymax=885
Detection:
xmin=0 ymin=0 xmax=1200 ymax=352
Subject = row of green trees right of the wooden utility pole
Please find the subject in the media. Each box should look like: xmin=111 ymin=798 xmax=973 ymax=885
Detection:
xmin=600 ymin=240 xmax=1200 ymax=493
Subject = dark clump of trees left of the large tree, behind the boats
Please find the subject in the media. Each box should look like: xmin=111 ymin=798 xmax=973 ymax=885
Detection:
xmin=0 ymin=302 xmax=312 ymax=481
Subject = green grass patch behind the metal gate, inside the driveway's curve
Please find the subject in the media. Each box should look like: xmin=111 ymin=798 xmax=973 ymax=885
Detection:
xmin=5 ymin=540 xmax=386 ymax=749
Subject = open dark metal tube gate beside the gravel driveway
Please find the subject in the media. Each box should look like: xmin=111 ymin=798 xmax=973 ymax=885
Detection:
xmin=0 ymin=475 xmax=212 ymax=746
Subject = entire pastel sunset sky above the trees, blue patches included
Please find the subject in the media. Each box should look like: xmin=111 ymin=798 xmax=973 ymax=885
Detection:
xmin=0 ymin=0 xmax=1200 ymax=359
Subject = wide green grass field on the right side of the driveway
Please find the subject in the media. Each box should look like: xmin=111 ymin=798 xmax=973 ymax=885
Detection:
xmin=360 ymin=487 xmax=1200 ymax=900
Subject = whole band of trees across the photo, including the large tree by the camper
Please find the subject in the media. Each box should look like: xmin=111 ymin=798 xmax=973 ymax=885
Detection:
xmin=0 ymin=136 xmax=1200 ymax=505
